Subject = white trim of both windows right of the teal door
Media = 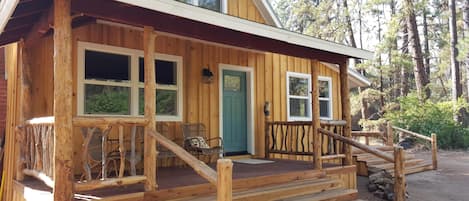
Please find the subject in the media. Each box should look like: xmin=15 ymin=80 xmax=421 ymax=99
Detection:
xmin=286 ymin=72 xmax=333 ymax=121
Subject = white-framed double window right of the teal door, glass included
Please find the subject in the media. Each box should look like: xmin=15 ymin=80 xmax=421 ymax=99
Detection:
xmin=287 ymin=72 xmax=332 ymax=121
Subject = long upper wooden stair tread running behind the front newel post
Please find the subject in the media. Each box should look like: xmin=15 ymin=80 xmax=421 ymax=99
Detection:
xmin=178 ymin=178 xmax=342 ymax=201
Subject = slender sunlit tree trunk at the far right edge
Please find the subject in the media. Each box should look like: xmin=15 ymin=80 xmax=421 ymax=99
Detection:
xmin=448 ymin=0 xmax=462 ymax=122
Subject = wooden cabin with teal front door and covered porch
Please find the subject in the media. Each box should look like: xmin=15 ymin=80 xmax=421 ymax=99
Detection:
xmin=0 ymin=0 xmax=373 ymax=201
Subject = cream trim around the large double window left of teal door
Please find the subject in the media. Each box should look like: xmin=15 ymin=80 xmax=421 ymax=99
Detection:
xmin=77 ymin=41 xmax=184 ymax=121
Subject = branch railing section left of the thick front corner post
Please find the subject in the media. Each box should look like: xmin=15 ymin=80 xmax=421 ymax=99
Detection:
xmin=17 ymin=117 xmax=55 ymax=187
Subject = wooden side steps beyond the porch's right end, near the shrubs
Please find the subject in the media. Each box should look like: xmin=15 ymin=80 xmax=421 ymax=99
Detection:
xmin=353 ymin=146 xmax=433 ymax=176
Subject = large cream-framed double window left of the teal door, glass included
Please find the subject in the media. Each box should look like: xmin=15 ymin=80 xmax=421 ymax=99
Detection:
xmin=78 ymin=42 xmax=183 ymax=121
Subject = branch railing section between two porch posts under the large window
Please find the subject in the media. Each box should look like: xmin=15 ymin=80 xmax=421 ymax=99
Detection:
xmin=73 ymin=117 xmax=148 ymax=191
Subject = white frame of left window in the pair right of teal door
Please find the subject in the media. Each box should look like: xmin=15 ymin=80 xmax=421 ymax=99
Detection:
xmin=286 ymin=72 xmax=312 ymax=121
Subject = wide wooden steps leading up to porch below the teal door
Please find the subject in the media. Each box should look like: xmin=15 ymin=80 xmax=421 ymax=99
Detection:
xmin=156 ymin=172 xmax=357 ymax=201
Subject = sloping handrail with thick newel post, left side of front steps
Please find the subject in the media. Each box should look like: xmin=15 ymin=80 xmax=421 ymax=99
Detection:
xmin=149 ymin=132 xmax=233 ymax=201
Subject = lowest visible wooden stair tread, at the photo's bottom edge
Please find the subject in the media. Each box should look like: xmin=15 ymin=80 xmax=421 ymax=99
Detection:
xmin=278 ymin=189 xmax=358 ymax=201
